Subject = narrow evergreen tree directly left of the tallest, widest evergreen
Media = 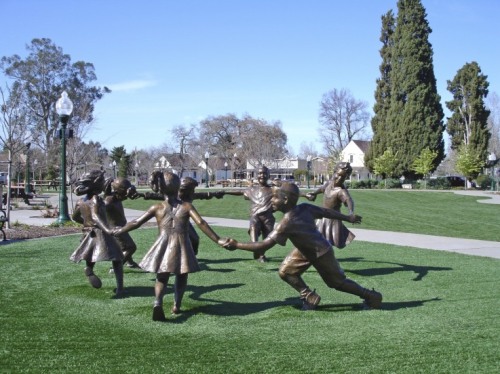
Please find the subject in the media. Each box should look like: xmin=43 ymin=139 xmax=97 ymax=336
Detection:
xmin=365 ymin=10 xmax=396 ymax=171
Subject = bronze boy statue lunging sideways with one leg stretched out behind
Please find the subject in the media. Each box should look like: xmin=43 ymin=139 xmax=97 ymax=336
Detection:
xmin=224 ymin=182 xmax=382 ymax=310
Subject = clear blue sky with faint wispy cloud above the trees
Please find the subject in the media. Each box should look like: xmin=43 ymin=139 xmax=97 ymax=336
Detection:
xmin=0 ymin=0 xmax=500 ymax=153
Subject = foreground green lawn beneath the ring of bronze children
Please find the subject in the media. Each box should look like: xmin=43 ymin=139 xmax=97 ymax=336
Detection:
xmin=0 ymin=226 xmax=500 ymax=373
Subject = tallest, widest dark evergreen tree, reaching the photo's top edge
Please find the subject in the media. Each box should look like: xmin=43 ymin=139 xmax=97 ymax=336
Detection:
xmin=385 ymin=0 xmax=445 ymax=178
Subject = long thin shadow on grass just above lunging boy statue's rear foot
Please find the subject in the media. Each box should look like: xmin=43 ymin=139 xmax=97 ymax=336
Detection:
xmin=339 ymin=257 xmax=453 ymax=281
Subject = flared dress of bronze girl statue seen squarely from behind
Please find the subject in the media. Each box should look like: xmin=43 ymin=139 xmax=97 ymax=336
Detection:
xmin=139 ymin=201 xmax=200 ymax=274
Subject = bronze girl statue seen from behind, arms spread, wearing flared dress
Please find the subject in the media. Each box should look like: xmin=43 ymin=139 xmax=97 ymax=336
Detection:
xmin=113 ymin=172 xmax=227 ymax=321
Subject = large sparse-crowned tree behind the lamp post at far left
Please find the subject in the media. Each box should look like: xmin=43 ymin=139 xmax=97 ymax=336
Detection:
xmin=0 ymin=38 xmax=111 ymax=164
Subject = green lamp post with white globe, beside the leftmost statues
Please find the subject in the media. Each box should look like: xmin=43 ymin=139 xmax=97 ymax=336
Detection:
xmin=56 ymin=91 xmax=73 ymax=224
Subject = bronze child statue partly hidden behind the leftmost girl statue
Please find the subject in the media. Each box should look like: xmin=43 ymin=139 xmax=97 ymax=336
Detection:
xmin=104 ymin=178 xmax=139 ymax=268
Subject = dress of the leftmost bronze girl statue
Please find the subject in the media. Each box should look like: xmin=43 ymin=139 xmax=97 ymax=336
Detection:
xmin=70 ymin=196 xmax=123 ymax=262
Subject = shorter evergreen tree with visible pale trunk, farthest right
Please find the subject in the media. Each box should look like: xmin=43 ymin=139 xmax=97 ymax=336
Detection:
xmin=446 ymin=62 xmax=491 ymax=160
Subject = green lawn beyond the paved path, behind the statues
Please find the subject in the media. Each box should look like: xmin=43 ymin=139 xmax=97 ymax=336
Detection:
xmin=124 ymin=189 xmax=500 ymax=241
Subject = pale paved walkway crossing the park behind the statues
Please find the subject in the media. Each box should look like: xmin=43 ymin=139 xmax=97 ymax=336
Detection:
xmin=3 ymin=191 xmax=500 ymax=259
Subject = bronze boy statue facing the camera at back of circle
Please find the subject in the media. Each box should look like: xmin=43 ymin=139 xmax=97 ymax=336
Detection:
xmin=225 ymin=166 xmax=276 ymax=262
